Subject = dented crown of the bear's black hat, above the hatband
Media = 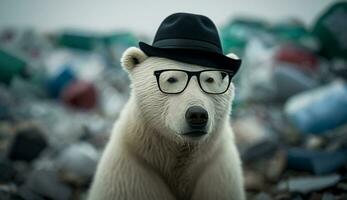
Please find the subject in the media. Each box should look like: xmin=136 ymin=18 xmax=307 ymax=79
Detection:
xmin=153 ymin=13 xmax=222 ymax=51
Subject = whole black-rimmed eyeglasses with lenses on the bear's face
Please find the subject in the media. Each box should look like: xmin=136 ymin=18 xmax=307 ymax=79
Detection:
xmin=154 ymin=69 xmax=234 ymax=94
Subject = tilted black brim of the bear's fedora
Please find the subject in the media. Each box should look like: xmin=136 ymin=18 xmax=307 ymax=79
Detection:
xmin=139 ymin=42 xmax=241 ymax=74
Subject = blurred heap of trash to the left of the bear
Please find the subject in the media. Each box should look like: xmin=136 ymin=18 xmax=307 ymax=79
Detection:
xmin=0 ymin=28 xmax=138 ymax=200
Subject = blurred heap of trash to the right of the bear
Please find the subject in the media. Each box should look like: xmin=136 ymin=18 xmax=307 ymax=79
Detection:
xmin=226 ymin=2 xmax=347 ymax=200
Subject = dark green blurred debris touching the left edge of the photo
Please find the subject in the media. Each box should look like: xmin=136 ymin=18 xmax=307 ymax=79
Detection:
xmin=0 ymin=49 xmax=26 ymax=84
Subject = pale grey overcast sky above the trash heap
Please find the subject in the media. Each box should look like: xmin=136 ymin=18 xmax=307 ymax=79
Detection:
xmin=0 ymin=0 xmax=336 ymax=35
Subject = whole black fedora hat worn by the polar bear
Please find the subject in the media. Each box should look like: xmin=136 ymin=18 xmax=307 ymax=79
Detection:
xmin=139 ymin=13 xmax=241 ymax=74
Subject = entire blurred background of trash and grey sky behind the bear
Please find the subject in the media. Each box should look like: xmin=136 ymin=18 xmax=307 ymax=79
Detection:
xmin=0 ymin=0 xmax=347 ymax=200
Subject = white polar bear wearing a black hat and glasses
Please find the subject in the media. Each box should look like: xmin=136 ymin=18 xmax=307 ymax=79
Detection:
xmin=89 ymin=47 xmax=245 ymax=200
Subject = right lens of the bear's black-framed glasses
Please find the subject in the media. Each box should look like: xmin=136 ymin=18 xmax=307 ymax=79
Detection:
xmin=200 ymin=71 xmax=230 ymax=94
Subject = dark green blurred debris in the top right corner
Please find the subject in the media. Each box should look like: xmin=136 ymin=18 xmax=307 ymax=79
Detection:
xmin=313 ymin=2 xmax=347 ymax=60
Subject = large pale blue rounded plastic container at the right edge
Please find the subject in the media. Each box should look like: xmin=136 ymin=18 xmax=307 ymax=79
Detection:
xmin=285 ymin=80 xmax=347 ymax=134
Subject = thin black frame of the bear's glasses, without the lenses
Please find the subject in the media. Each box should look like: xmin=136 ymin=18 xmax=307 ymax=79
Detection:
xmin=154 ymin=69 xmax=234 ymax=94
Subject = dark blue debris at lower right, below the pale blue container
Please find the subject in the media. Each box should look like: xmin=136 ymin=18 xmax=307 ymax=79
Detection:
xmin=287 ymin=148 xmax=347 ymax=174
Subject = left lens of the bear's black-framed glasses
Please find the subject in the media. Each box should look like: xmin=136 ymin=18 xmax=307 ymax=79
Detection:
xmin=159 ymin=71 xmax=188 ymax=93
